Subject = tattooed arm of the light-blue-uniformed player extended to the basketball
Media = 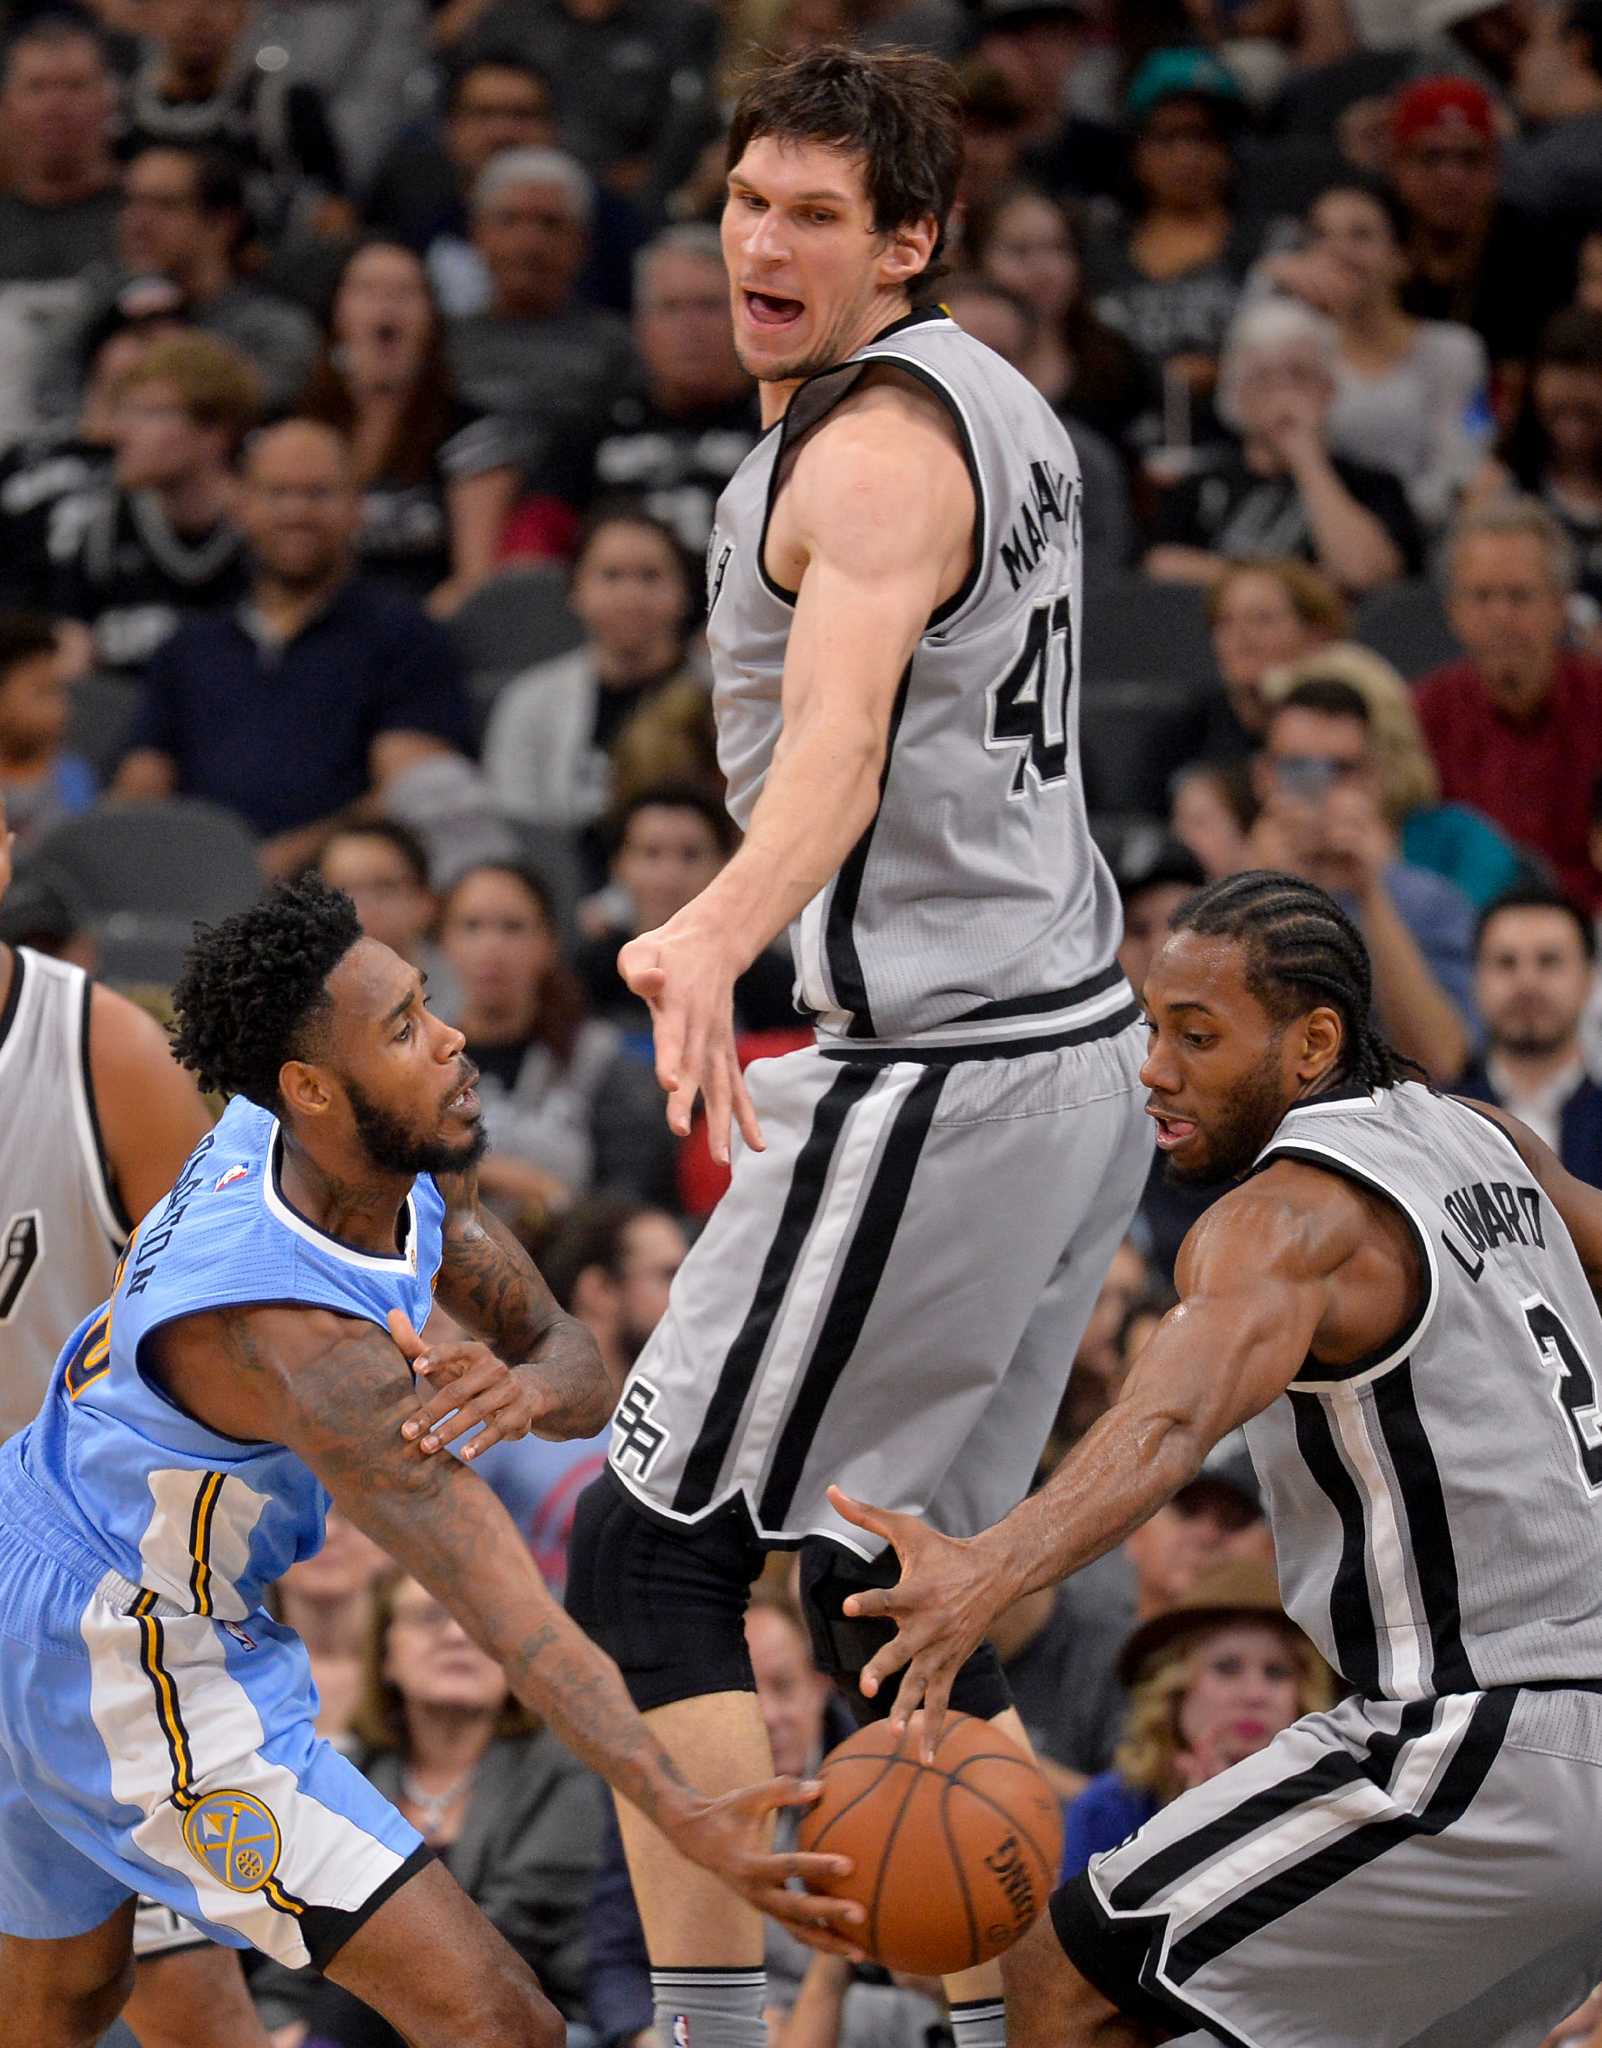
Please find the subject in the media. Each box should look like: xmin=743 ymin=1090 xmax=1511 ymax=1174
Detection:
xmin=208 ymin=1309 xmax=860 ymax=1946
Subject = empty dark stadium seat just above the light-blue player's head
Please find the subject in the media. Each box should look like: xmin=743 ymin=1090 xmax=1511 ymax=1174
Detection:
xmin=39 ymin=797 xmax=262 ymax=985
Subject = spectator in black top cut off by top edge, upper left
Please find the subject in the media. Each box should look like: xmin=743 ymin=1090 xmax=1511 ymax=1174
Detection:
xmin=121 ymin=0 xmax=356 ymax=244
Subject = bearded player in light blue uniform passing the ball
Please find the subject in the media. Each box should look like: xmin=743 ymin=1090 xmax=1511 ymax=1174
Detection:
xmin=0 ymin=881 xmax=854 ymax=2048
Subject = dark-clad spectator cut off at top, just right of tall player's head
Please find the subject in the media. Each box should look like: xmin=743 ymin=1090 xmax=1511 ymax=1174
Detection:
xmin=975 ymin=0 xmax=1125 ymax=197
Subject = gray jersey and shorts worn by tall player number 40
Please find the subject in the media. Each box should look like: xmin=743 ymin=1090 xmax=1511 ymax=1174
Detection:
xmin=610 ymin=311 xmax=1149 ymax=1556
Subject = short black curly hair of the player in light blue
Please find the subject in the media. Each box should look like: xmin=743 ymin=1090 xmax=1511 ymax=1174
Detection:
xmin=172 ymin=874 xmax=361 ymax=1110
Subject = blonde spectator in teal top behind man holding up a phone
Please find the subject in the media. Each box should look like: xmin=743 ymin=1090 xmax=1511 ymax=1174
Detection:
xmin=1266 ymin=641 xmax=1530 ymax=907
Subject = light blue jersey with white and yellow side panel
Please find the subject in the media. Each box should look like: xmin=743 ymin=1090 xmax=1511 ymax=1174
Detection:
xmin=16 ymin=1098 xmax=445 ymax=1622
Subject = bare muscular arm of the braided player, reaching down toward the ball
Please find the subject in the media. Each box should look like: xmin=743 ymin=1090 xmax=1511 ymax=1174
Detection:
xmin=832 ymin=1165 xmax=1364 ymax=1745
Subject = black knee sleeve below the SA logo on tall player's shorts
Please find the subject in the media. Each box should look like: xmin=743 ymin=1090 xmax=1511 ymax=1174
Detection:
xmin=567 ymin=1473 xmax=762 ymax=1712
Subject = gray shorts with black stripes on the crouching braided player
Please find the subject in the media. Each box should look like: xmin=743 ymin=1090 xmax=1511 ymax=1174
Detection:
xmin=1051 ymin=1686 xmax=1602 ymax=2048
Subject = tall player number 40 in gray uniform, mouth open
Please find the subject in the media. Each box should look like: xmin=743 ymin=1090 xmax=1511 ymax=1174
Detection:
xmin=567 ymin=36 xmax=1149 ymax=2048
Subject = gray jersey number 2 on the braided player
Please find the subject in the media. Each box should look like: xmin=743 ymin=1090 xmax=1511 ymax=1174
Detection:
xmin=1246 ymin=1081 xmax=1602 ymax=1700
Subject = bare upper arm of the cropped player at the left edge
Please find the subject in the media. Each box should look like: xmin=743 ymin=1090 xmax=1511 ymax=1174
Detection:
xmin=88 ymin=985 xmax=211 ymax=1225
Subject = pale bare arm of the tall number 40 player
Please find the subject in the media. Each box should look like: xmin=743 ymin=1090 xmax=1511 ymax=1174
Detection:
xmin=619 ymin=387 xmax=973 ymax=1159
